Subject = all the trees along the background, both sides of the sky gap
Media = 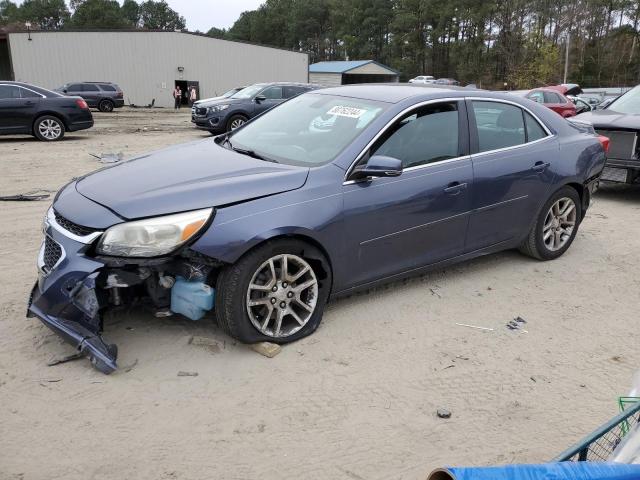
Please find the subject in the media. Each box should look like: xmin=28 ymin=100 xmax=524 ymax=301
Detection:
xmin=0 ymin=0 xmax=640 ymax=89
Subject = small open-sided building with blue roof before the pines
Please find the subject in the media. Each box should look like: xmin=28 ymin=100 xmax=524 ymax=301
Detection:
xmin=309 ymin=60 xmax=400 ymax=87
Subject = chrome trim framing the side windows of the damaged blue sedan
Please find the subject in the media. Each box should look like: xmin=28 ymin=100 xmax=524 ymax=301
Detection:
xmin=342 ymin=97 xmax=556 ymax=185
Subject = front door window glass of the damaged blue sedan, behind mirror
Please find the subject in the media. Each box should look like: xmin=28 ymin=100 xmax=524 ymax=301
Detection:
xmin=370 ymin=102 xmax=460 ymax=168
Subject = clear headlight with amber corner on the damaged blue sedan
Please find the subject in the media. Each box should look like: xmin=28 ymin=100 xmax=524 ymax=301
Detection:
xmin=97 ymin=208 xmax=213 ymax=257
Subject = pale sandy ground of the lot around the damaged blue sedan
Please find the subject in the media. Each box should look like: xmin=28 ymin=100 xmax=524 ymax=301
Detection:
xmin=0 ymin=110 xmax=640 ymax=480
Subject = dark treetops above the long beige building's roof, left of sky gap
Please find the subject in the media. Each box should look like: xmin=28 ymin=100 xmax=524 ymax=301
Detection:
xmin=0 ymin=0 xmax=186 ymax=30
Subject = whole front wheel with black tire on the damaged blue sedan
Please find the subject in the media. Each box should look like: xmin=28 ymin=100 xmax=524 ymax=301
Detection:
xmin=215 ymin=239 xmax=332 ymax=344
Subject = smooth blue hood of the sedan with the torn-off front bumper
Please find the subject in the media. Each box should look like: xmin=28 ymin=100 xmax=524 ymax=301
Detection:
xmin=76 ymin=139 xmax=309 ymax=219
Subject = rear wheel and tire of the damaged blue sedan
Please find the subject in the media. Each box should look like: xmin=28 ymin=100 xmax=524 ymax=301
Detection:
xmin=520 ymin=186 xmax=582 ymax=260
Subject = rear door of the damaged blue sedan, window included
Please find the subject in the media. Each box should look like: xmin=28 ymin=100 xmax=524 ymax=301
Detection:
xmin=466 ymin=99 xmax=558 ymax=251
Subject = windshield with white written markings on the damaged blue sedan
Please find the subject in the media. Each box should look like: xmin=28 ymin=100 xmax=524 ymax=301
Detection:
xmin=229 ymin=93 xmax=388 ymax=167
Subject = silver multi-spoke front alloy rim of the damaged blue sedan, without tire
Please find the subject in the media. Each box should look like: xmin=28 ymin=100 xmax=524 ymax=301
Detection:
xmin=246 ymin=254 xmax=318 ymax=338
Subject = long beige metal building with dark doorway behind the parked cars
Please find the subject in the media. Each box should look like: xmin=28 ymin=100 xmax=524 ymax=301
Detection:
xmin=0 ymin=31 xmax=309 ymax=107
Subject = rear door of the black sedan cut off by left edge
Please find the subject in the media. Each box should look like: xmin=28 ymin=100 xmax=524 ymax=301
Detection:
xmin=0 ymin=84 xmax=42 ymax=133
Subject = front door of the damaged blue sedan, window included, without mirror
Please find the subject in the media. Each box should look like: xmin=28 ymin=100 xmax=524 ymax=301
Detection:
xmin=343 ymin=101 xmax=473 ymax=288
